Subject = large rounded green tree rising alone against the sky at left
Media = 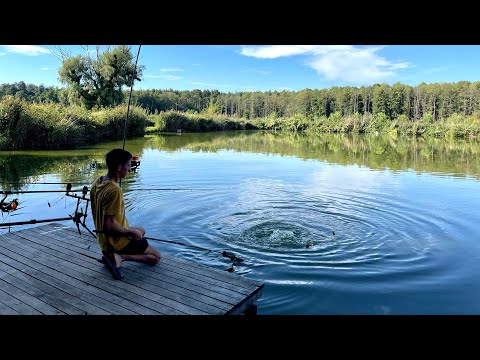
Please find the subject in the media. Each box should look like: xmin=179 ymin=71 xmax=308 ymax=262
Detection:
xmin=58 ymin=45 xmax=145 ymax=109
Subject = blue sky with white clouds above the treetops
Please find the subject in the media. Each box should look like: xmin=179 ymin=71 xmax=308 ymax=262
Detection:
xmin=0 ymin=45 xmax=480 ymax=92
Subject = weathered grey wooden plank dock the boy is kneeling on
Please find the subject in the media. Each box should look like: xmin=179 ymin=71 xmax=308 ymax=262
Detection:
xmin=0 ymin=223 xmax=264 ymax=315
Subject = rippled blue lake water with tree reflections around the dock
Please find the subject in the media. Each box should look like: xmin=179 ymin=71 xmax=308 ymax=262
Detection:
xmin=0 ymin=132 xmax=480 ymax=314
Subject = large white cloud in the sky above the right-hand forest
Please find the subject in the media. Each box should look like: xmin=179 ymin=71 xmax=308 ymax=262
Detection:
xmin=240 ymin=45 xmax=411 ymax=84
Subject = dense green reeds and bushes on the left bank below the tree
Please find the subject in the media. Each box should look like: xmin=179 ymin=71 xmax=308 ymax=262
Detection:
xmin=0 ymin=95 xmax=148 ymax=150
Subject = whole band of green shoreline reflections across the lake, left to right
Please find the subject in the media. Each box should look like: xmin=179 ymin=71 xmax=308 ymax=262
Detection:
xmin=0 ymin=131 xmax=480 ymax=190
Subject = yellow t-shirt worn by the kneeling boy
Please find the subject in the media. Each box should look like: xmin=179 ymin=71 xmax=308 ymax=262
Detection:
xmin=90 ymin=176 xmax=130 ymax=251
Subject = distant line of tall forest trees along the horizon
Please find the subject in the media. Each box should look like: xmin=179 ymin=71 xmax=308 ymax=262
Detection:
xmin=0 ymin=80 xmax=480 ymax=121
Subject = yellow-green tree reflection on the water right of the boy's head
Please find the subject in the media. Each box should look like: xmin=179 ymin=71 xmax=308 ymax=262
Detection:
xmin=151 ymin=131 xmax=480 ymax=176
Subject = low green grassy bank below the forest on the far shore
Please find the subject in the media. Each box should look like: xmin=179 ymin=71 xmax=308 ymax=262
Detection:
xmin=146 ymin=111 xmax=480 ymax=138
